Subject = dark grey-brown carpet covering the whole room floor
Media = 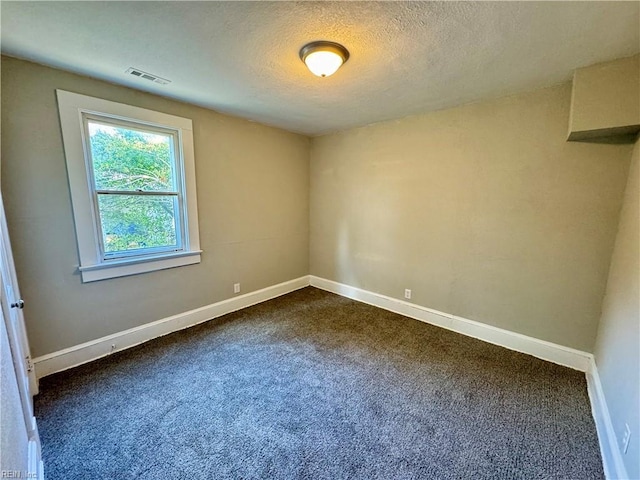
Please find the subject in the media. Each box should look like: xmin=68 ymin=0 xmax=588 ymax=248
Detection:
xmin=35 ymin=287 xmax=603 ymax=480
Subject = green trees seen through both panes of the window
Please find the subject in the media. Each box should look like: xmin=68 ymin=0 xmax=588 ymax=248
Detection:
xmin=88 ymin=120 xmax=179 ymax=256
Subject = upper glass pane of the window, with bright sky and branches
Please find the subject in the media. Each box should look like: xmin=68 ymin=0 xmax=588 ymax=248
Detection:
xmin=87 ymin=120 xmax=176 ymax=192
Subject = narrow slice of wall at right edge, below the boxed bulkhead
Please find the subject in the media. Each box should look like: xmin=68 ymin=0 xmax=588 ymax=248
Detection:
xmin=595 ymin=139 xmax=640 ymax=478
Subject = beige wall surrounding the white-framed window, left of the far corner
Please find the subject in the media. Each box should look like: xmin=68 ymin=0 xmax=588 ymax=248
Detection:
xmin=2 ymin=57 xmax=309 ymax=356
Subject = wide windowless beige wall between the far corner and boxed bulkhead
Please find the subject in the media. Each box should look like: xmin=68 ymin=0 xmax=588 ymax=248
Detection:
xmin=310 ymin=84 xmax=632 ymax=351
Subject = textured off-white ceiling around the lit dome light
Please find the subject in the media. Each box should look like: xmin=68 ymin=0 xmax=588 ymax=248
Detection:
xmin=0 ymin=1 xmax=640 ymax=135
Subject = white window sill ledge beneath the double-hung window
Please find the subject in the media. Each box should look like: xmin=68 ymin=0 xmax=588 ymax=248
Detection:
xmin=78 ymin=250 xmax=202 ymax=283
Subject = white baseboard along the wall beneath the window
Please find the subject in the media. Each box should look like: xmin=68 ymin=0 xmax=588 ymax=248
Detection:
xmin=33 ymin=275 xmax=309 ymax=379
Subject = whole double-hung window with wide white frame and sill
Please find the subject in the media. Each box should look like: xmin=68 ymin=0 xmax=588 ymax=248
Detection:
xmin=57 ymin=90 xmax=201 ymax=282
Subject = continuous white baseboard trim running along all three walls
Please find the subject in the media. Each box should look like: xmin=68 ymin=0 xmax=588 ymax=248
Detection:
xmin=33 ymin=275 xmax=616 ymax=479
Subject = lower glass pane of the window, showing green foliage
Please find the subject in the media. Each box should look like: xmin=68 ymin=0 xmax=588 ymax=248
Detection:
xmin=98 ymin=194 xmax=178 ymax=253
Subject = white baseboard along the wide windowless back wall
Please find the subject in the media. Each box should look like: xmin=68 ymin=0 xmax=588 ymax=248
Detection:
xmin=310 ymin=275 xmax=593 ymax=372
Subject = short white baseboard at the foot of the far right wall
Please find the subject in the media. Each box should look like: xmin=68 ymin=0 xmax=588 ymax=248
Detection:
xmin=587 ymin=360 xmax=629 ymax=480
